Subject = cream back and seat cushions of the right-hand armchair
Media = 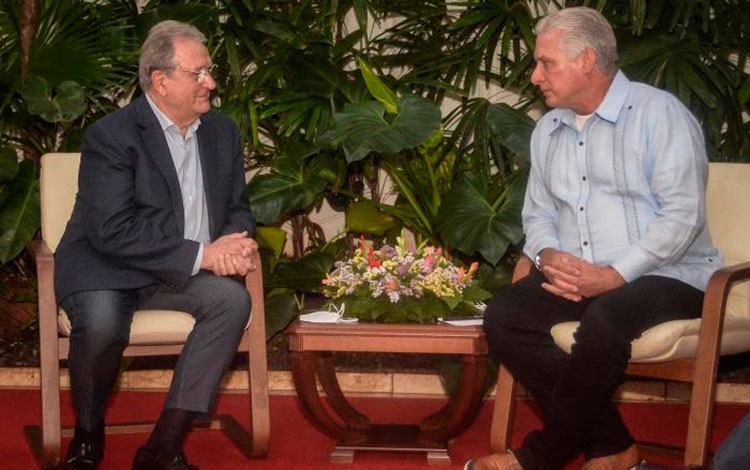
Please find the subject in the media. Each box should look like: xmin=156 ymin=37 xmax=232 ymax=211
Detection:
xmin=550 ymin=163 xmax=750 ymax=362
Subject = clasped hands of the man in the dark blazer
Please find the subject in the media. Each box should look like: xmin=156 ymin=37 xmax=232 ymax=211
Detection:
xmin=201 ymin=231 xmax=258 ymax=276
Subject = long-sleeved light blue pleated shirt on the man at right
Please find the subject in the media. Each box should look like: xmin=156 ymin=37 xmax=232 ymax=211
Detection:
xmin=523 ymin=71 xmax=724 ymax=290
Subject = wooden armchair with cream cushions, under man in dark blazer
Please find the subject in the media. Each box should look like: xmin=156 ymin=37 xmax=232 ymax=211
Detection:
xmin=25 ymin=154 xmax=270 ymax=468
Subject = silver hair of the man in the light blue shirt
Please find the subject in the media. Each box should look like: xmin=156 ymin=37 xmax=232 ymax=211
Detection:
xmin=534 ymin=7 xmax=617 ymax=76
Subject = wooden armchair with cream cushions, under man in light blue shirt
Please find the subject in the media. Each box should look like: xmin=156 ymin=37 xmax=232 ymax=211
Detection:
xmin=490 ymin=163 xmax=750 ymax=467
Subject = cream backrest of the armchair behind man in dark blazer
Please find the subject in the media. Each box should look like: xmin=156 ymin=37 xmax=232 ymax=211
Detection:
xmin=39 ymin=153 xmax=81 ymax=253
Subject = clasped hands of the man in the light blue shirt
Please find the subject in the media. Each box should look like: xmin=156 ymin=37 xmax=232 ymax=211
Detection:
xmin=540 ymin=248 xmax=625 ymax=302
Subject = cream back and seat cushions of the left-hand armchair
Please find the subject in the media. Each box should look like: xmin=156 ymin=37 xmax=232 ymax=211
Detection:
xmin=39 ymin=153 xmax=195 ymax=345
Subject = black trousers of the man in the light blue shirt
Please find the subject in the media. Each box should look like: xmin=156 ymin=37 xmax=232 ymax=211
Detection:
xmin=484 ymin=271 xmax=703 ymax=470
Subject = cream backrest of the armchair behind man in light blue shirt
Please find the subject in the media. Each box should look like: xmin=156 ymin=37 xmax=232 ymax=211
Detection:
xmin=706 ymin=163 xmax=750 ymax=318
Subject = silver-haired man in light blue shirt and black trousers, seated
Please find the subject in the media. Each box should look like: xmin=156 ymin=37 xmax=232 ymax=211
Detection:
xmin=466 ymin=7 xmax=723 ymax=470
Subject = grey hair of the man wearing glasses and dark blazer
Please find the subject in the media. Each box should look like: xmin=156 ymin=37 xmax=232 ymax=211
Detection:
xmin=138 ymin=20 xmax=206 ymax=93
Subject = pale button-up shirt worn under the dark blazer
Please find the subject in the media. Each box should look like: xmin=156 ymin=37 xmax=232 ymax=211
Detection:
xmin=146 ymin=93 xmax=211 ymax=276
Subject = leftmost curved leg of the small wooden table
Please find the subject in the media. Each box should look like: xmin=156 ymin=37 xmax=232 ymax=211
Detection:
xmin=291 ymin=351 xmax=366 ymax=442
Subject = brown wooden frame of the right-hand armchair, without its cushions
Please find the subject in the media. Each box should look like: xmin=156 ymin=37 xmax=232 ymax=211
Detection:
xmin=490 ymin=257 xmax=750 ymax=467
